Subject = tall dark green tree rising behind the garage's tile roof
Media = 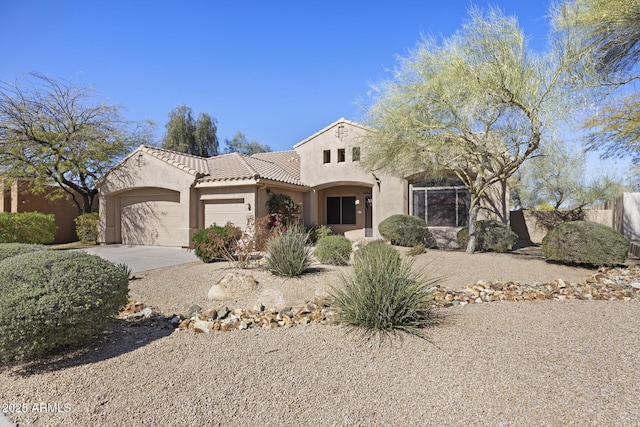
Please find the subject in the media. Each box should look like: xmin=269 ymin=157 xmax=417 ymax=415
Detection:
xmin=162 ymin=105 xmax=218 ymax=157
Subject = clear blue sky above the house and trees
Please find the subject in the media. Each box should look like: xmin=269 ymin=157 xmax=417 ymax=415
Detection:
xmin=0 ymin=0 xmax=560 ymax=154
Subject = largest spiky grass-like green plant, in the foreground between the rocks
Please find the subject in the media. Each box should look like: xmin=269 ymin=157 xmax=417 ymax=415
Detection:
xmin=332 ymin=242 xmax=435 ymax=340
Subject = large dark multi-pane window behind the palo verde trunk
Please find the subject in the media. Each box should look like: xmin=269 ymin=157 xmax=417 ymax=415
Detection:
xmin=413 ymin=180 xmax=471 ymax=227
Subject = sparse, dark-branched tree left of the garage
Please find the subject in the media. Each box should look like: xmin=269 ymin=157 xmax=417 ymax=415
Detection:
xmin=0 ymin=73 xmax=150 ymax=213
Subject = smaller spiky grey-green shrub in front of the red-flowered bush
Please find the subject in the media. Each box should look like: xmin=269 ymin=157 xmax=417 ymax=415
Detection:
xmin=265 ymin=227 xmax=311 ymax=277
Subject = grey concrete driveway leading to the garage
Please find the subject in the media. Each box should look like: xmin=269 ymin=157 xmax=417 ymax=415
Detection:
xmin=78 ymin=245 xmax=198 ymax=273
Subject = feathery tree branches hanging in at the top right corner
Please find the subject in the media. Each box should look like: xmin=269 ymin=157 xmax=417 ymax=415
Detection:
xmin=553 ymin=0 xmax=640 ymax=164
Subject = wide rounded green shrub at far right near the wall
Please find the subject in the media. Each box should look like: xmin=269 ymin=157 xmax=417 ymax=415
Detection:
xmin=542 ymin=221 xmax=629 ymax=266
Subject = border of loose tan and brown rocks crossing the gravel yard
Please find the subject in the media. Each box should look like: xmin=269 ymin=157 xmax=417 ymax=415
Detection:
xmin=112 ymin=267 xmax=640 ymax=333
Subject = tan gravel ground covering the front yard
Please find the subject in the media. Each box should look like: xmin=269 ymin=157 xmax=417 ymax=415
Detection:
xmin=0 ymin=251 xmax=640 ymax=426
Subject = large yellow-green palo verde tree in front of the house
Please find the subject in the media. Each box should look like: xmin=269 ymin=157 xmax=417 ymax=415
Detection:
xmin=363 ymin=8 xmax=571 ymax=253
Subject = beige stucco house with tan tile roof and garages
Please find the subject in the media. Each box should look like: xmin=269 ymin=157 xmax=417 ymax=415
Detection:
xmin=97 ymin=119 xmax=508 ymax=246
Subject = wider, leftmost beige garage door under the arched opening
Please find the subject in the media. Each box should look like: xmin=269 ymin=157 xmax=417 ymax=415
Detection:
xmin=120 ymin=190 xmax=184 ymax=246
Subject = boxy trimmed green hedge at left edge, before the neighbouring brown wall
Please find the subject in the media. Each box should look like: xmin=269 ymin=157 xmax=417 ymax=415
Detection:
xmin=0 ymin=212 xmax=56 ymax=245
